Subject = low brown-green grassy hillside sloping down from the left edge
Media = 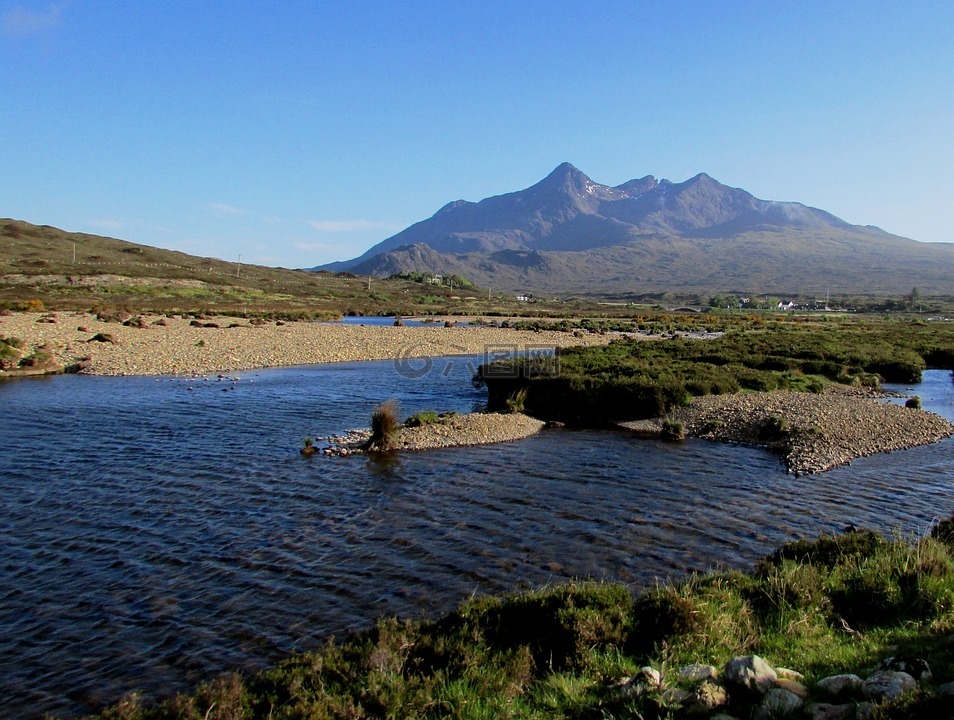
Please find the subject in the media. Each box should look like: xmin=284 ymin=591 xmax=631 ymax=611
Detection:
xmin=0 ymin=218 xmax=516 ymax=317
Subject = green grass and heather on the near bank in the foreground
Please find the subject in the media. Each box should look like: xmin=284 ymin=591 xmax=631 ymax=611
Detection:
xmin=80 ymin=518 xmax=954 ymax=720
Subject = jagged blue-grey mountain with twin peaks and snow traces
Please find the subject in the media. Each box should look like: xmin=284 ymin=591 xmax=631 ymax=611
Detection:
xmin=314 ymin=163 xmax=954 ymax=294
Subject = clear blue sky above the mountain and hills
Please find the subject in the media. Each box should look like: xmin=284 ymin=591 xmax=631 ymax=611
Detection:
xmin=0 ymin=0 xmax=954 ymax=267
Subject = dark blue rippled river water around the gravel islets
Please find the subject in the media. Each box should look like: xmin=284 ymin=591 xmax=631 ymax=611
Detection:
xmin=0 ymin=358 xmax=954 ymax=717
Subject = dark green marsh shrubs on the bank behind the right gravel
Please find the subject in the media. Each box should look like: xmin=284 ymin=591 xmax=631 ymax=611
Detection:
xmin=480 ymin=318 xmax=954 ymax=422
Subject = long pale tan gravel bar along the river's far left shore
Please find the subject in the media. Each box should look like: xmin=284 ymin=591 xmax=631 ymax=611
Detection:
xmin=0 ymin=312 xmax=610 ymax=375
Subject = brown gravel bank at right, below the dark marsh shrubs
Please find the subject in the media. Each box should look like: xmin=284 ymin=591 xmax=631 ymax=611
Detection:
xmin=625 ymin=387 xmax=954 ymax=475
